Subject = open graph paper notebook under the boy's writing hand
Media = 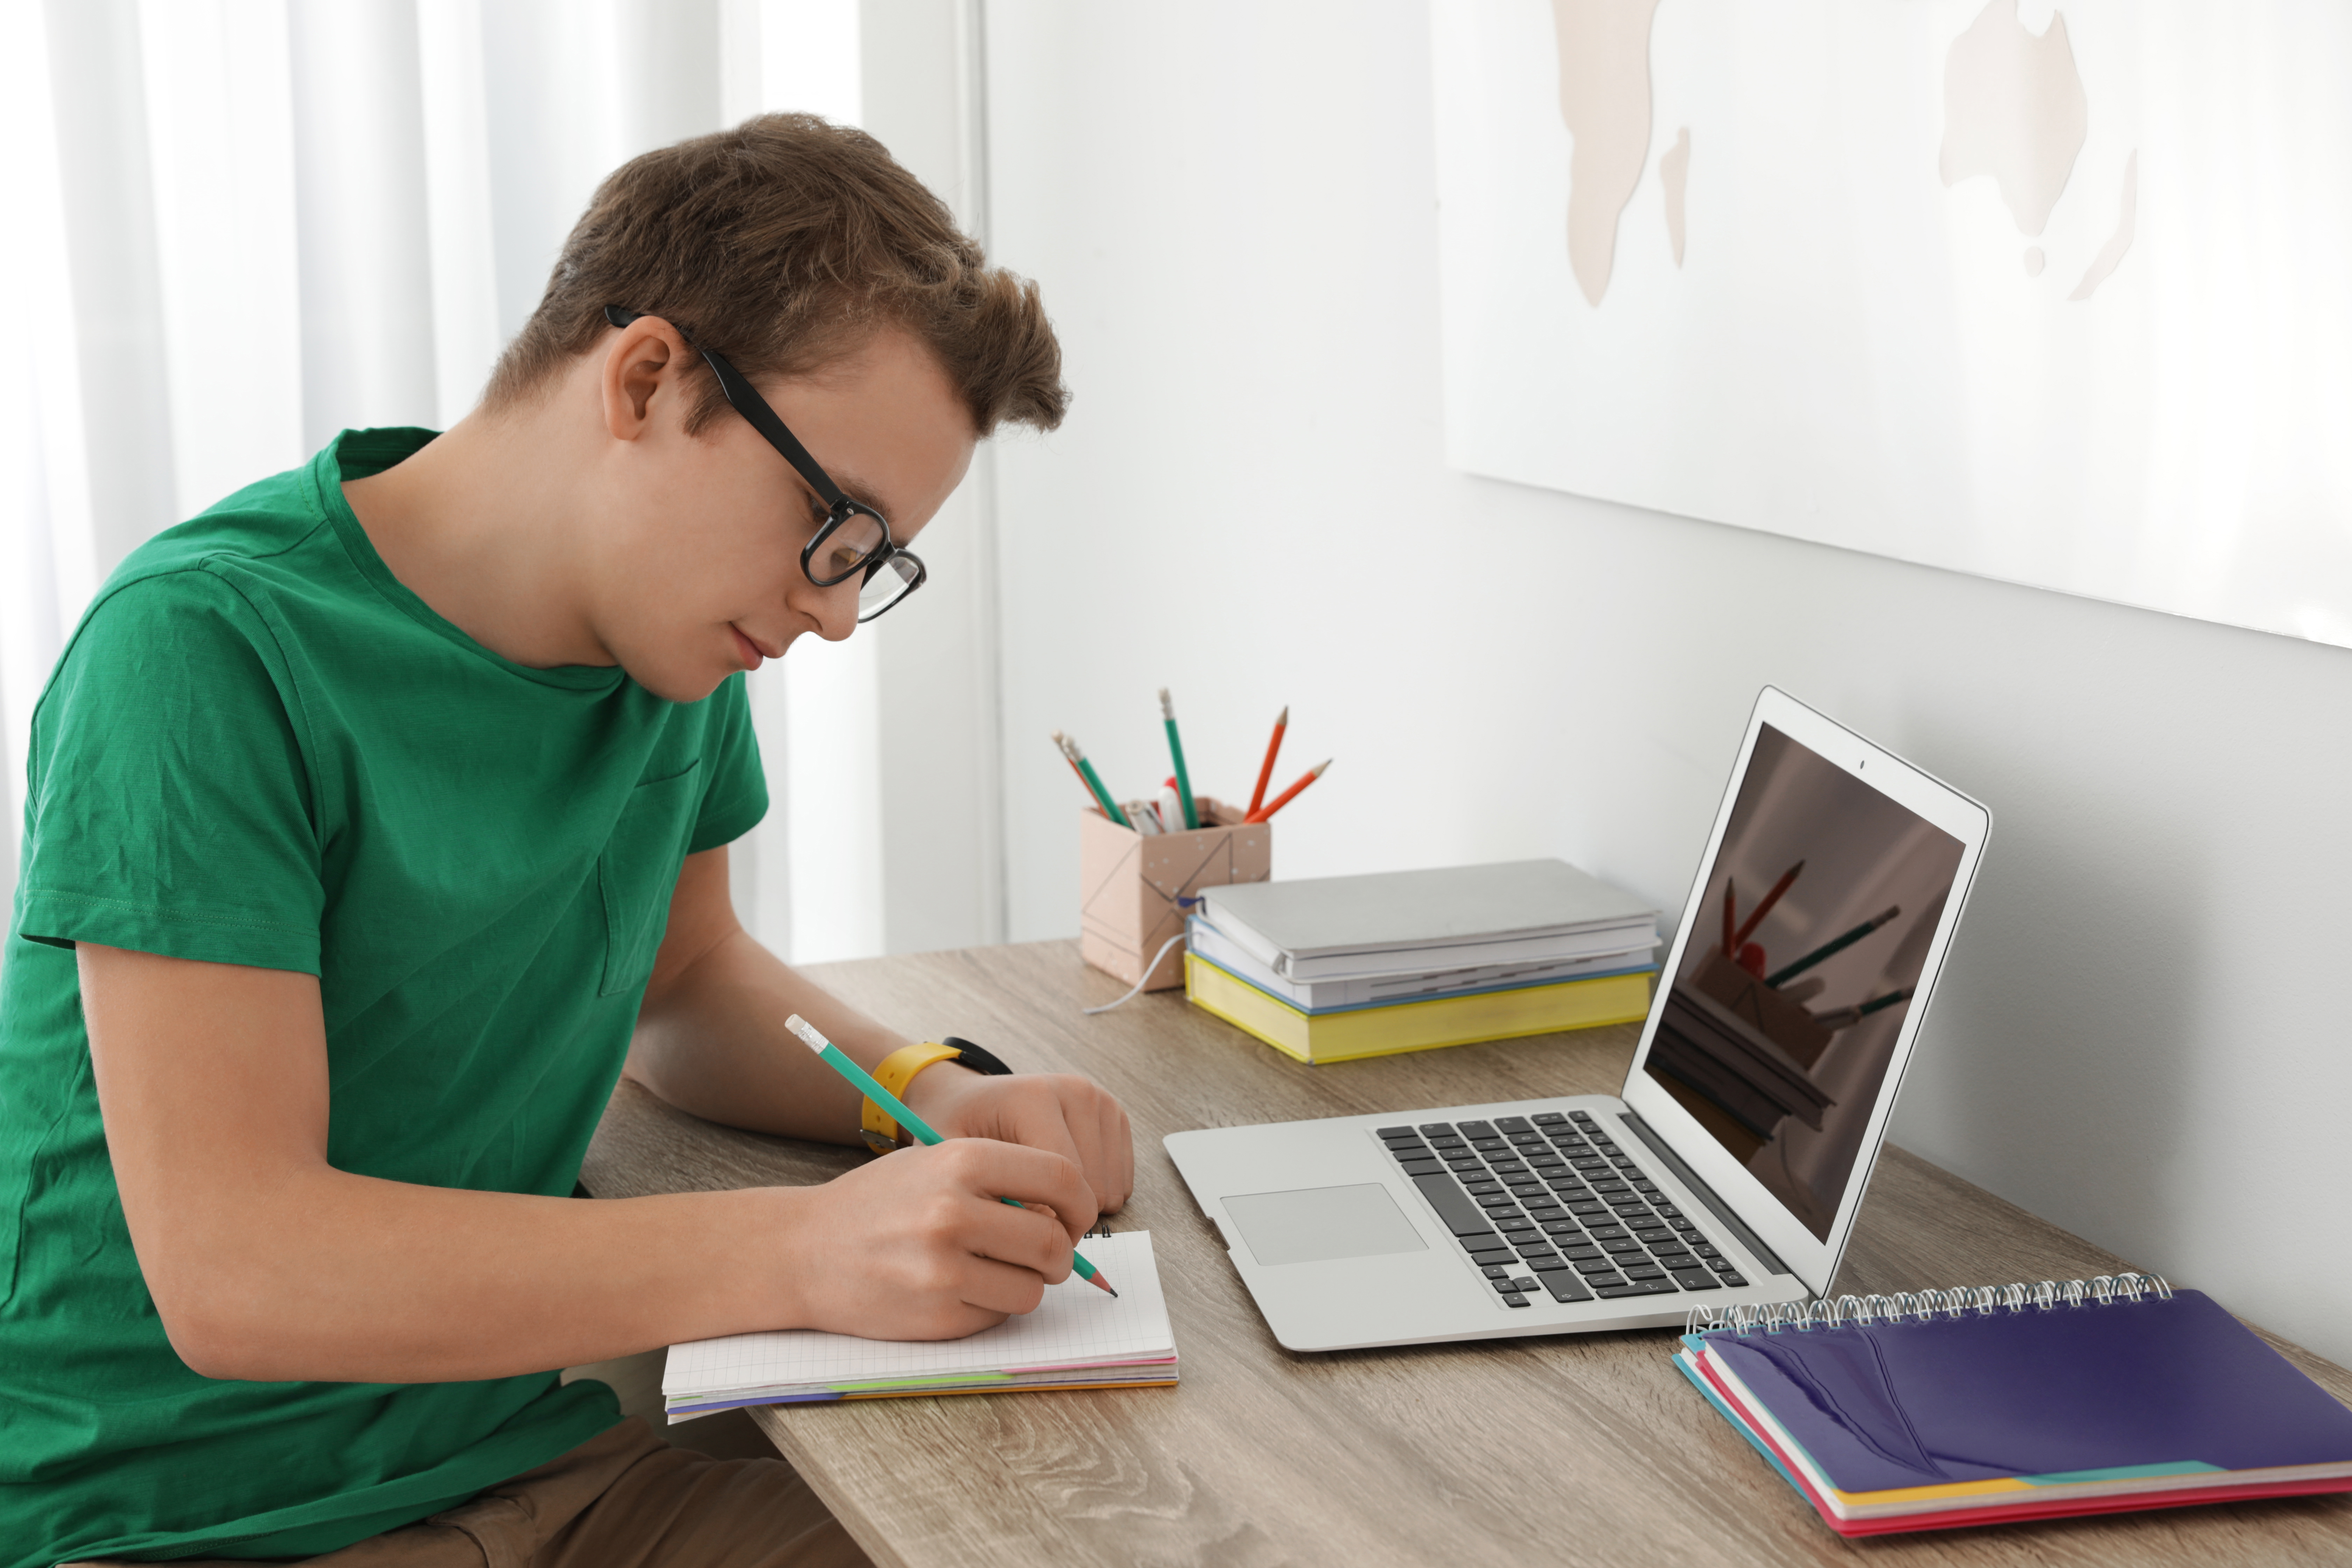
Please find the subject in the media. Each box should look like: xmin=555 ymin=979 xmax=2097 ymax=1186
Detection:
xmin=661 ymin=1230 xmax=1176 ymax=1422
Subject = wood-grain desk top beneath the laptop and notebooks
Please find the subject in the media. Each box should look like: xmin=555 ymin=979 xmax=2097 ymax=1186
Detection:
xmin=586 ymin=943 xmax=2352 ymax=1568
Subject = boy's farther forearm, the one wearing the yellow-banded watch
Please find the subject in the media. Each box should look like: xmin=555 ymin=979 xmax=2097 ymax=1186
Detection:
xmin=628 ymin=929 xmax=908 ymax=1142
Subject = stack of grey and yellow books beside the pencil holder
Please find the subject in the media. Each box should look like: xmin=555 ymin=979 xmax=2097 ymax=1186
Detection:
xmin=1185 ymin=860 xmax=1658 ymax=1063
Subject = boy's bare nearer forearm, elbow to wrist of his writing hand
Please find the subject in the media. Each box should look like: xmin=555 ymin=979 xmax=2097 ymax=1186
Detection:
xmin=150 ymin=1166 xmax=807 ymax=1382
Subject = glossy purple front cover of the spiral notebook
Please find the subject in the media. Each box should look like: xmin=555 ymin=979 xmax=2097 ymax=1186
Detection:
xmin=1703 ymin=1290 xmax=2352 ymax=1493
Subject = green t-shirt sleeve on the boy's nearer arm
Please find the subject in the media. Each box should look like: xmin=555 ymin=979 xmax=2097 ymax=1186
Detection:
xmin=16 ymin=569 xmax=324 ymax=975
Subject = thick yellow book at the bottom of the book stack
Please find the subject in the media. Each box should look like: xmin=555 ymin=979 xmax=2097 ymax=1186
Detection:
xmin=1183 ymin=952 xmax=1651 ymax=1063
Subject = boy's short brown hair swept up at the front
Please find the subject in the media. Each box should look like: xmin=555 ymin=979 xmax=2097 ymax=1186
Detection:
xmin=482 ymin=115 xmax=1070 ymax=435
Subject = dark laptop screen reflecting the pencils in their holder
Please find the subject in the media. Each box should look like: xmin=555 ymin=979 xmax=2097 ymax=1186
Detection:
xmin=1644 ymin=724 xmax=1961 ymax=1241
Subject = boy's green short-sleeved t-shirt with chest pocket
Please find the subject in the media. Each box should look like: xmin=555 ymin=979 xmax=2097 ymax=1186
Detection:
xmin=0 ymin=430 xmax=767 ymax=1568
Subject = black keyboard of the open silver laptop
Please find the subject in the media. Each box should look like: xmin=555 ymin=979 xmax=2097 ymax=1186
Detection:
xmin=1378 ymin=1110 xmax=1748 ymax=1307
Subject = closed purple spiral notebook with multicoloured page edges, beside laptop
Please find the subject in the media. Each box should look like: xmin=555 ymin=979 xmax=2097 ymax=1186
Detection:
xmin=1675 ymin=1274 xmax=2352 ymax=1535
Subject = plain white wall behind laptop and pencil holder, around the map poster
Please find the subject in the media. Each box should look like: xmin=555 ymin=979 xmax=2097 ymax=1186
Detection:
xmin=988 ymin=0 xmax=2352 ymax=1361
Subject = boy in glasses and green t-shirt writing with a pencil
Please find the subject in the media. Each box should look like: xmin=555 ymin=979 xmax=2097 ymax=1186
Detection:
xmin=0 ymin=115 xmax=1134 ymax=1568
